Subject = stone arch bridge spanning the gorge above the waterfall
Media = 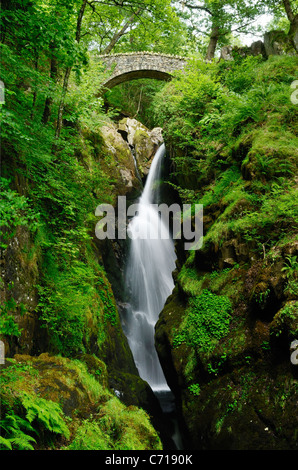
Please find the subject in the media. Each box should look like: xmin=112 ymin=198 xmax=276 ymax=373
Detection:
xmin=98 ymin=52 xmax=186 ymax=88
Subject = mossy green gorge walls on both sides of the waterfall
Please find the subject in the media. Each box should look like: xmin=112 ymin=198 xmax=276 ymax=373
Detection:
xmin=0 ymin=37 xmax=298 ymax=450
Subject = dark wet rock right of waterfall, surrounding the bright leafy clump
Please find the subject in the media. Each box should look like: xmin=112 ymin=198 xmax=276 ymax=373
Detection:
xmin=155 ymin=233 xmax=298 ymax=450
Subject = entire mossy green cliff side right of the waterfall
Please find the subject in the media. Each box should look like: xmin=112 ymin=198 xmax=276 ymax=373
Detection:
xmin=151 ymin=55 xmax=298 ymax=450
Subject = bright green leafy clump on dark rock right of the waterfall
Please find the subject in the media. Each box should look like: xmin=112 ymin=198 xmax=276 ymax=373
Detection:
xmin=173 ymin=289 xmax=232 ymax=353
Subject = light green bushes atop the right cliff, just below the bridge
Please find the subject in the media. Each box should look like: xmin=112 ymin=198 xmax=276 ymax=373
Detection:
xmin=154 ymin=57 xmax=296 ymax=164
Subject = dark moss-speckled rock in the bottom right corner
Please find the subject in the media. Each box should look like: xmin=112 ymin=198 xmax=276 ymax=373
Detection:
xmin=183 ymin=363 xmax=297 ymax=450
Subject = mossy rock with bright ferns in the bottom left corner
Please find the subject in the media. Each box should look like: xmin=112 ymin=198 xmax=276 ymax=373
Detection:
xmin=0 ymin=354 xmax=162 ymax=450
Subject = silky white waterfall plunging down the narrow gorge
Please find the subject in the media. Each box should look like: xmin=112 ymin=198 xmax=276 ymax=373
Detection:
xmin=125 ymin=145 xmax=176 ymax=391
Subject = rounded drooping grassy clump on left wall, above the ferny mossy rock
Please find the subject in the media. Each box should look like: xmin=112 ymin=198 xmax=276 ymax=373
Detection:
xmin=38 ymin=257 xmax=118 ymax=356
